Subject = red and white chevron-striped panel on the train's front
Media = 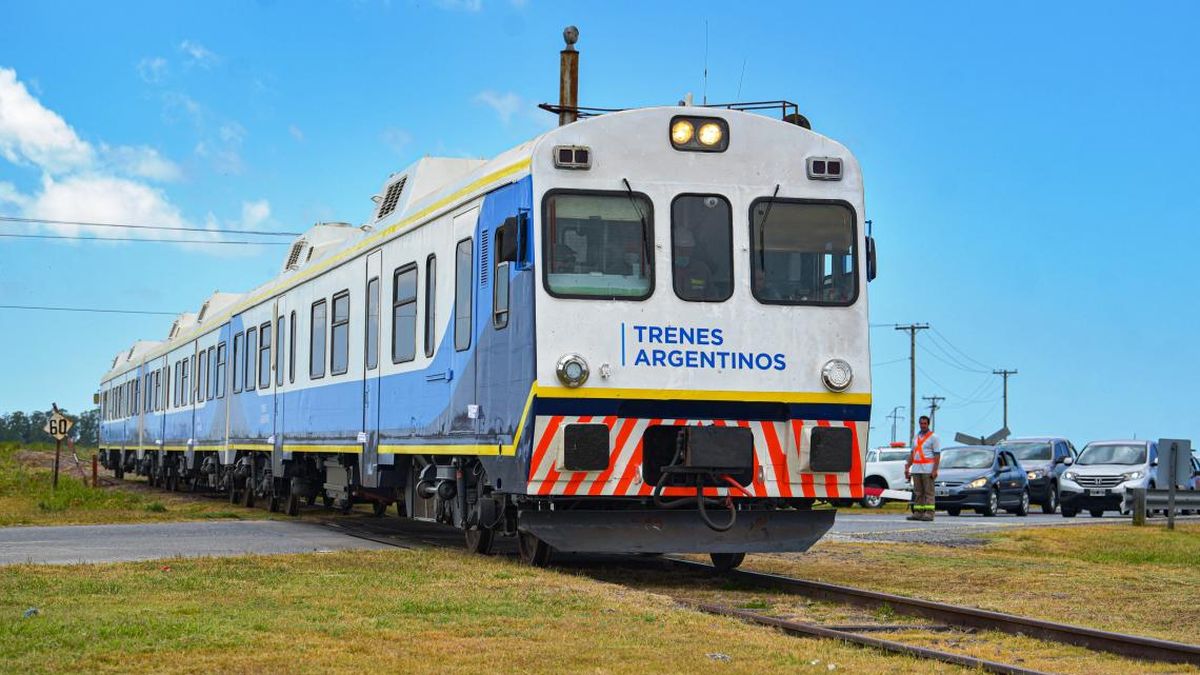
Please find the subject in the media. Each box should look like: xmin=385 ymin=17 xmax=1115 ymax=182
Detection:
xmin=527 ymin=416 xmax=868 ymax=498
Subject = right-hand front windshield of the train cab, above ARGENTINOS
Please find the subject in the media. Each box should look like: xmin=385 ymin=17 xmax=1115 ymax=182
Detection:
xmin=750 ymin=198 xmax=858 ymax=306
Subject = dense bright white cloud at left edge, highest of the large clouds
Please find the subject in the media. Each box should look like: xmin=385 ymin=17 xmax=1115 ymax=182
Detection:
xmin=0 ymin=67 xmax=94 ymax=173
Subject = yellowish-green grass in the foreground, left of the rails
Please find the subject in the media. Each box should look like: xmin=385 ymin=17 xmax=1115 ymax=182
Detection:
xmin=0 ymin=550 xmax=959 ymax=673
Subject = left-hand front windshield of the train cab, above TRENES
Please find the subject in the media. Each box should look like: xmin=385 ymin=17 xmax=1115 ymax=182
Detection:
xmin=542 ymin=186 xmax=654 ymax=300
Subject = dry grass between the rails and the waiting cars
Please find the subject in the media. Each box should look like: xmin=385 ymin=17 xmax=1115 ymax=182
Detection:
xmin=746 ymin=524 xmax=1200 ymax=644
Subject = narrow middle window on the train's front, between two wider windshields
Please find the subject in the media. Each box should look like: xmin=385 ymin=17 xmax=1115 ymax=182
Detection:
xmin=671 ymin=195 xmax=733 ymax=303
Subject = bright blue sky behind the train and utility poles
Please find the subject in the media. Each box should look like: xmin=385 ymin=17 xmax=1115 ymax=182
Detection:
xmin=0 ymin=0 xmax=1200 ymax=446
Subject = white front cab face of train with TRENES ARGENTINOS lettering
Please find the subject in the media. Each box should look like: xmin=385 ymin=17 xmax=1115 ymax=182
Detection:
xmin=518 ymin=108 xmax=870 ymax=563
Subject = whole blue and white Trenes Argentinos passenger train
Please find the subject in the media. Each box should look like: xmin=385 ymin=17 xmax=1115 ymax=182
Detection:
xmin=96 ymin=30 xmax=876 ymax=569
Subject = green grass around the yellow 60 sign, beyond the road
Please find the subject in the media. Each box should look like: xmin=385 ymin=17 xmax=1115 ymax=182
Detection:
xmin=0 ymin=443 xmax=261 ymax=526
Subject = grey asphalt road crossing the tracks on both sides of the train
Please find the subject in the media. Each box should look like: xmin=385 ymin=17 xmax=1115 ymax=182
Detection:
xmin=0 ymin=508 xmax=1196 ymax=565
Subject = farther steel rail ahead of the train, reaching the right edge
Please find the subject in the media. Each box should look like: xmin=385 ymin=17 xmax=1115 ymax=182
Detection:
xmin=668 ymin=557 xmax=1200 ymax=665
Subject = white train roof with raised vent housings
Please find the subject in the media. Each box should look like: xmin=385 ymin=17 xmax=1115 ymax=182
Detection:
xmin=101 ymin=106 xmax=854 ymax=382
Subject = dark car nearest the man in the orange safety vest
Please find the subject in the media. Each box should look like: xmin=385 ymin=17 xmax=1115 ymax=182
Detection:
xmin=934 ymin=446 xmax=1030 ymax=515
